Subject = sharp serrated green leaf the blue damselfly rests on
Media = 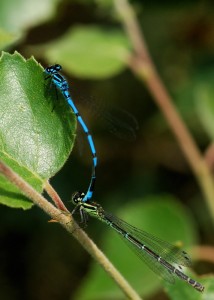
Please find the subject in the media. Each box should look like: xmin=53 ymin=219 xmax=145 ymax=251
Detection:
xmin=0 ymin=53 xmax=76 ymax=208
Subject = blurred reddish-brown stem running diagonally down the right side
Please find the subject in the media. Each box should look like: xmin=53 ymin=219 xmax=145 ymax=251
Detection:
xmin=114 ymin=0 xmax=214 ymax=221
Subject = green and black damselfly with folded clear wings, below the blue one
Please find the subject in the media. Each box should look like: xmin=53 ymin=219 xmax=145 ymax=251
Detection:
xmin=72 ymin=192 xmax=204 ymax=292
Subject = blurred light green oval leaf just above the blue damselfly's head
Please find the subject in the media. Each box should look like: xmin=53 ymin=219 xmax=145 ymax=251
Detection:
xmin=40 ymin=26 xmax=130 ymax=79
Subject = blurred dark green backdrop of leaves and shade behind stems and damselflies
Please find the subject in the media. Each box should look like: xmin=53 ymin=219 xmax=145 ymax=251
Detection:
xmin=0 ymin=0 xmax=214 ymax=300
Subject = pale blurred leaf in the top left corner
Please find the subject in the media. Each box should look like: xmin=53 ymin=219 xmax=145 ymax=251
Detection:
xmin=0 ymin=0 xmax=59 ymax=33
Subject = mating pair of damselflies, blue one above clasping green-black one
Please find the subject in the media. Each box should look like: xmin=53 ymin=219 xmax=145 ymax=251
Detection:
xmin=45 ymin=65 xmax=204 ymax=292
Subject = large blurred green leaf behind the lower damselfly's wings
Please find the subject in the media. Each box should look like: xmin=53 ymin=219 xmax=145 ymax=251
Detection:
xmin=76 ymin=195 xmax=200 ymax=300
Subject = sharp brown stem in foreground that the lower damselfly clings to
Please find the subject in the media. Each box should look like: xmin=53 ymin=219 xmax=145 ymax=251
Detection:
xmin=0 ymin=161 xmax=141 ymax=300
